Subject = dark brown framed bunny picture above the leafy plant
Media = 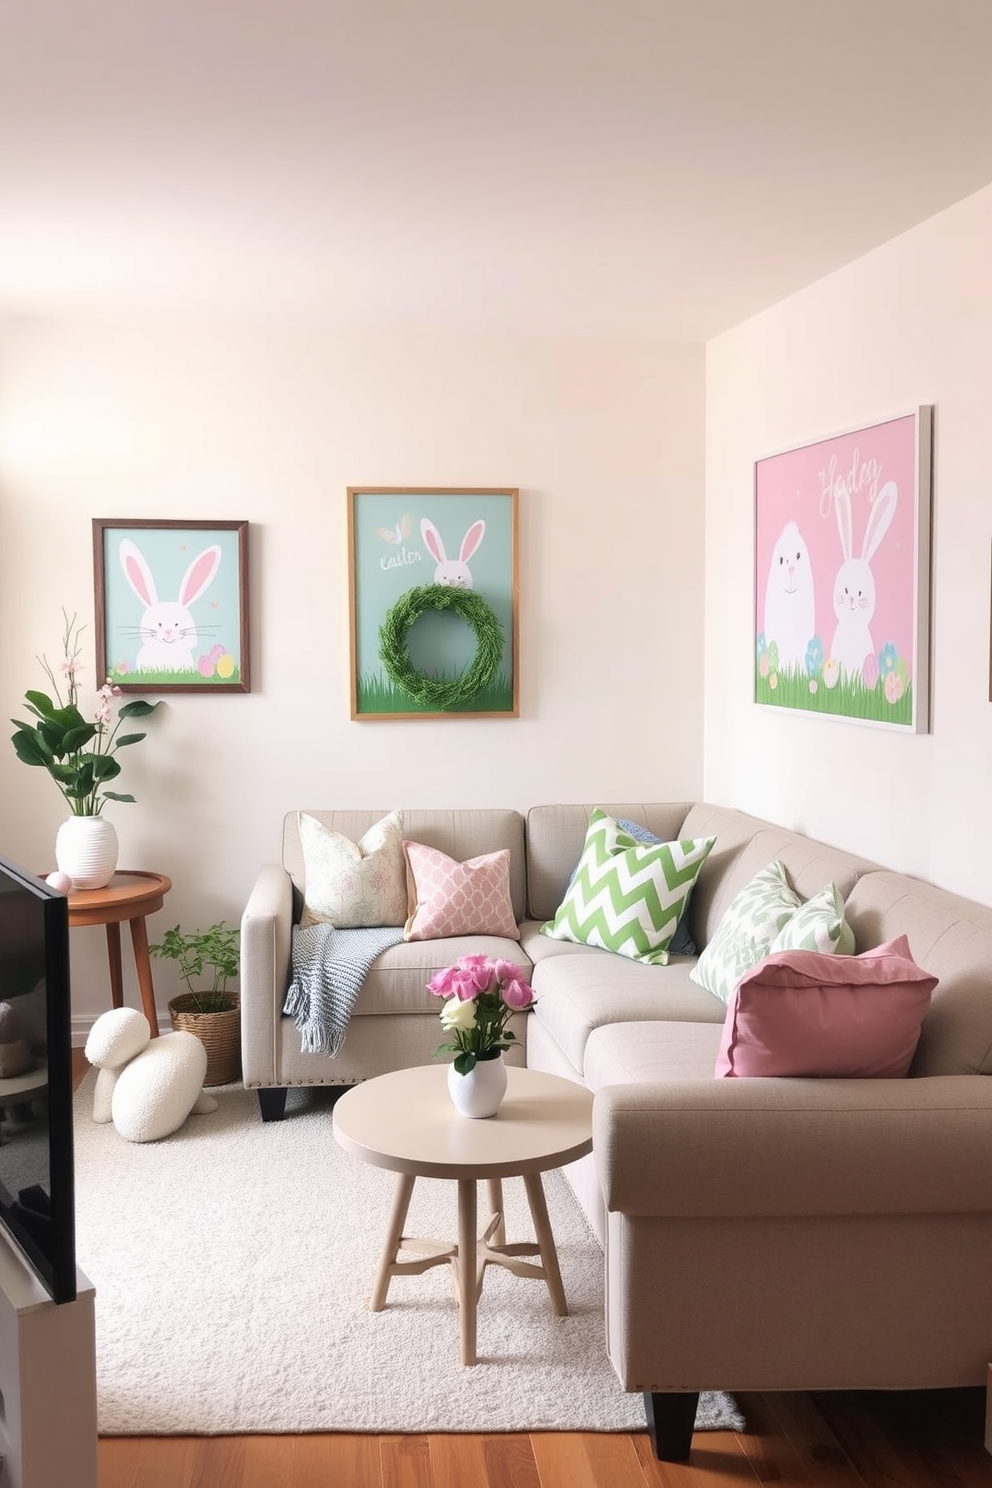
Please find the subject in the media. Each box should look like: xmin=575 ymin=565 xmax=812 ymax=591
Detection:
xmin=92 ymin=516 xmax=251 ymax=692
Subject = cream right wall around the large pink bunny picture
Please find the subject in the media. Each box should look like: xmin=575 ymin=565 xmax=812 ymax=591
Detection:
xmin=705 ymin=187 xmax=992 ymax=903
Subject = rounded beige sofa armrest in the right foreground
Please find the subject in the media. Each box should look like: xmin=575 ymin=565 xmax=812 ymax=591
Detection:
xmin=593 ymin=1074 xmax=992 ymax=1219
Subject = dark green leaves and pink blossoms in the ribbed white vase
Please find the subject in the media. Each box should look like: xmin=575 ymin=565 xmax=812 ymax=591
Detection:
xmin=10 ymin=610 xmax=159 ymax=817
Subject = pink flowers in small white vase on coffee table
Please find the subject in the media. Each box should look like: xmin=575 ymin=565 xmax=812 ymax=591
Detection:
xmin=427 ymin=955 xmax=534 ymax=1116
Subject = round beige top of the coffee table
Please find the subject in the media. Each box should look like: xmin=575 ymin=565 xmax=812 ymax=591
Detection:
xmin=333 ymin=1064 xmax=592 ymax=1178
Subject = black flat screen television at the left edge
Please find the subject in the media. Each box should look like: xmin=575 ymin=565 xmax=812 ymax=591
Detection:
xmin=0 ymin=856 xmax=76 ymax=1302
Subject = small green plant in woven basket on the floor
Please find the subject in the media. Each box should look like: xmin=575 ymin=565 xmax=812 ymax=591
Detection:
xmin=149 ymin=920 xmax=241 ymax=1085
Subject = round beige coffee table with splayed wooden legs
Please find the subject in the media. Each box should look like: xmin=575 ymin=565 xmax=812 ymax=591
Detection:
xmin=333 ymin=1064 xmax=592 ymax=1364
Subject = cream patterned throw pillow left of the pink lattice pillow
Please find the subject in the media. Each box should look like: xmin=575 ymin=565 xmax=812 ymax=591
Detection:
xmin=297 ymin=811 xmax=406 ymax=930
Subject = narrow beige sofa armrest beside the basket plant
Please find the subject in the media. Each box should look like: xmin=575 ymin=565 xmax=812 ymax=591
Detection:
xmin=241 ymin=863 xmax=293 ymax=1085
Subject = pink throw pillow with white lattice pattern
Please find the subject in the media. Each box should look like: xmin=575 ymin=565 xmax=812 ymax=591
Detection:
xmin=403 ymin=842 xmax=521 ymax=940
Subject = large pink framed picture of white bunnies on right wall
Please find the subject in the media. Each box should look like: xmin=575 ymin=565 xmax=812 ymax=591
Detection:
xmin=754 ymin=406 xmax=933 ymax=734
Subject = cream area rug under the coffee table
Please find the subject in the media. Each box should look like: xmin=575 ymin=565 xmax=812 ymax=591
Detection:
xmin=74 ymin=1074 xmax=744 ymax=1436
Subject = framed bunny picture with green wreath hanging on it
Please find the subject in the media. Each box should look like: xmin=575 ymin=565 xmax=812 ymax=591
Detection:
xmin=348 ymin=487 xmax=519 ymax=720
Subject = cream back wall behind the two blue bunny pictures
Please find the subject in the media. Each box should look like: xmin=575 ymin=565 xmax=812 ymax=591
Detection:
xmin=0 ymin=318 xmax=703 ymax=1031
